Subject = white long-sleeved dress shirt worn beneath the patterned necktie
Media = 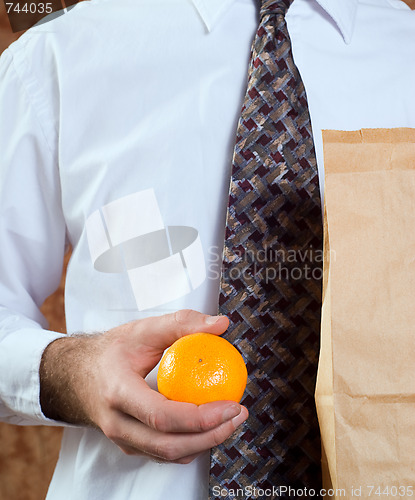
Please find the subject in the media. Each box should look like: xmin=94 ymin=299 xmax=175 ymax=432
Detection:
xmin=0 ymin=0 xmax=415 ymax=500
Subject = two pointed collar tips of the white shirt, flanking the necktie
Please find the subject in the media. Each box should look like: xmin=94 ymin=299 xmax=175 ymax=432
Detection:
xmin=191 ymin=0 xmax=358 ymax=43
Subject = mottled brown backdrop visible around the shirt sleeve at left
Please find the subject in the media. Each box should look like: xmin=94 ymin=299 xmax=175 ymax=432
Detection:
xmin=0 ymin=0 xmax=77 ymax=500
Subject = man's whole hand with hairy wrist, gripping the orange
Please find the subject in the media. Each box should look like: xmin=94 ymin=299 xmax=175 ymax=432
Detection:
xmin=40 ymin=310 xmax=248 ymax=463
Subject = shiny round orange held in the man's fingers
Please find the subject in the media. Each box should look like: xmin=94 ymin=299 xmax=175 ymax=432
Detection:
xmin=157 ymin=333 xmax=248 ymax=405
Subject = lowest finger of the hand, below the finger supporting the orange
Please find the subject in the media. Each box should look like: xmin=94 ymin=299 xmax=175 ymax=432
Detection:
xmin=108 ymin=407 xmax=248 ymax=463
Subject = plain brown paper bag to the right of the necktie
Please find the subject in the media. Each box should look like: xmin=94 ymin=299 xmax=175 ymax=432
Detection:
xmin=316 ymin=129 xmax=415 ymax=499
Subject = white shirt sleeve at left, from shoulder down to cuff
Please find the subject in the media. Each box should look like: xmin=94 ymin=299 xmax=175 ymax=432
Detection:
xmin=0 ymin=46 xmax=66 ymax=425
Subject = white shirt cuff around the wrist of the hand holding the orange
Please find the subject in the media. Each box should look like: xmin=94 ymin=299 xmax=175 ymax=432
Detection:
xmin=0 ymin=328 xmax=66 ymax=426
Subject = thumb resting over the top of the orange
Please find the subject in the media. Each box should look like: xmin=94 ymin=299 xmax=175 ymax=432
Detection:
xmin=136 ymin=309 xmax=229 ymax=350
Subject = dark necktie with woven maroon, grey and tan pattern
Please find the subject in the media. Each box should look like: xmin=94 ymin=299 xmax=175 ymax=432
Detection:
xmin=210 ymin=0 xmax=322 ymax=500
